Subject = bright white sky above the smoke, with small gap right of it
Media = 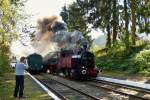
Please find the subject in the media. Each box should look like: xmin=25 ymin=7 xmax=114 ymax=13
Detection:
xmin=25 ymin=0 xmax=102 ymax=39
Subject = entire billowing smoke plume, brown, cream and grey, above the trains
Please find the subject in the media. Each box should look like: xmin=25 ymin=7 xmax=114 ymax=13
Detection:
xmin=10 ymin=16 xmax=87 ymax=57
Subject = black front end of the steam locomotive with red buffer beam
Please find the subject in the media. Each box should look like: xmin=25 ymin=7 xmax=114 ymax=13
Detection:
xmin=71 ymin=51 xmax=99 ymax=79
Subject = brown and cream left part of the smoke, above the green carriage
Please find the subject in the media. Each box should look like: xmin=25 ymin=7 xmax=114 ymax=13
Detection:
xmin=28 ymin=16 xmax=59 ymax=56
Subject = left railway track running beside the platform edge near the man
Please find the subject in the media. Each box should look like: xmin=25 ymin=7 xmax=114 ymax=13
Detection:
xmin=35 ymin=76 xmax=99 ymax=100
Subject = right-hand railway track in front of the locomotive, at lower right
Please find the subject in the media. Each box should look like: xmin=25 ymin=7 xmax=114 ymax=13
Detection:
xmin=85 ymin=80 xmax=150 ymax=100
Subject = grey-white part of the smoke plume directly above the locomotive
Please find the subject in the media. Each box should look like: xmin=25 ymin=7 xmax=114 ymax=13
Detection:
xmin=53 ymin=30 xmax=87 ymax=50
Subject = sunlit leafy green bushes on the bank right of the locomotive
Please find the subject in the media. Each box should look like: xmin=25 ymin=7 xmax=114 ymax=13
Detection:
xmin=96 ymin=43 xmax=150 ymax=75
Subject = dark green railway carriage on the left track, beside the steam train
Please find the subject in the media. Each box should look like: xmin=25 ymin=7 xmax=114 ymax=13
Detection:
xmin=27 ymin=53 xmax=43 ymax=73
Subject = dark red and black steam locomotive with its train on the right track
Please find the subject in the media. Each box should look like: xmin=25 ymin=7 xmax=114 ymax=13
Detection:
xmin=43 ymin=50 xmax=99 ymax=80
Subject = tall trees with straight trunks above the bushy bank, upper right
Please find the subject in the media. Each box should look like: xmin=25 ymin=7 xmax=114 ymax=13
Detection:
xmin=61 ymin=0 xmax=150 ymax=49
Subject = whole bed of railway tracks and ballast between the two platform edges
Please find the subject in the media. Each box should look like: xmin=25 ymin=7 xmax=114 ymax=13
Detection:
xmin=33 ymin=74 xmax=150 ymax=100
